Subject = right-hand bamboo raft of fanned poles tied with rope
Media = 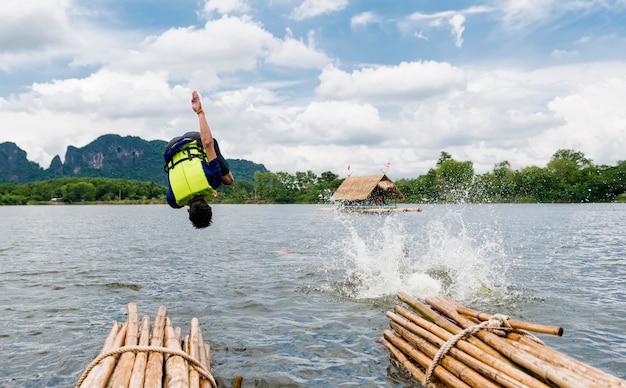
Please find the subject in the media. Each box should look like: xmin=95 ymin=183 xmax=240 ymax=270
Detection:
xmin=381 ymin=292 xmax=626 ymax=388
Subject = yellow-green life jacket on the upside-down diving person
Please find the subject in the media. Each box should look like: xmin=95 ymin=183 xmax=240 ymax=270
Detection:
xmin=165 ymin=141 xmax=215 ymax=206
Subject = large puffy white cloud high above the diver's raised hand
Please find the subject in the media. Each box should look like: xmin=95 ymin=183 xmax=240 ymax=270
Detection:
xmin=108 ymin=16 xmax=330 ymax=80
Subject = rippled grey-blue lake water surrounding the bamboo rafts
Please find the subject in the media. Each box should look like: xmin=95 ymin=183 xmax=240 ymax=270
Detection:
xmin=0 ymin=204 xmax=626 ymax=387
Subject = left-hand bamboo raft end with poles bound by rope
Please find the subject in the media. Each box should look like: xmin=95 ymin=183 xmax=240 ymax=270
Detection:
xmin=75 ymin=303 xmax=243 ymax=388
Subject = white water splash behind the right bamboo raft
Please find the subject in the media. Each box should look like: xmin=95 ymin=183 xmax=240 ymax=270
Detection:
xmin=330 ymin=208 xmax=504 ymax=300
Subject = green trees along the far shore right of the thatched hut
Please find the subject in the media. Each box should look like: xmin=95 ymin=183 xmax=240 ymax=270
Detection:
xmin=395 ymin=149 xmax=626 ymax=203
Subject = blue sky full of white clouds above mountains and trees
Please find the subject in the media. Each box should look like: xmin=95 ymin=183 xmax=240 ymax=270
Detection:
xmin=0 ymin=0 xmax=626 ymax=179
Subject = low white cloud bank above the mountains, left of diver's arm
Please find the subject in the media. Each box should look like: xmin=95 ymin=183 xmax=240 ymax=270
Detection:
xmin=0 ymin=70 xmax=191 ymax=168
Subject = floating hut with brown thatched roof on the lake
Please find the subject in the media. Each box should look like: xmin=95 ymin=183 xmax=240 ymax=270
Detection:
xmin=332 ymin=174 xmax=404 ymax=202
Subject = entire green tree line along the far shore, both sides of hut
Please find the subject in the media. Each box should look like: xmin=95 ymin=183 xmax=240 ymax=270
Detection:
xmin=0 ymin=150 xmax=626 ymax=205
